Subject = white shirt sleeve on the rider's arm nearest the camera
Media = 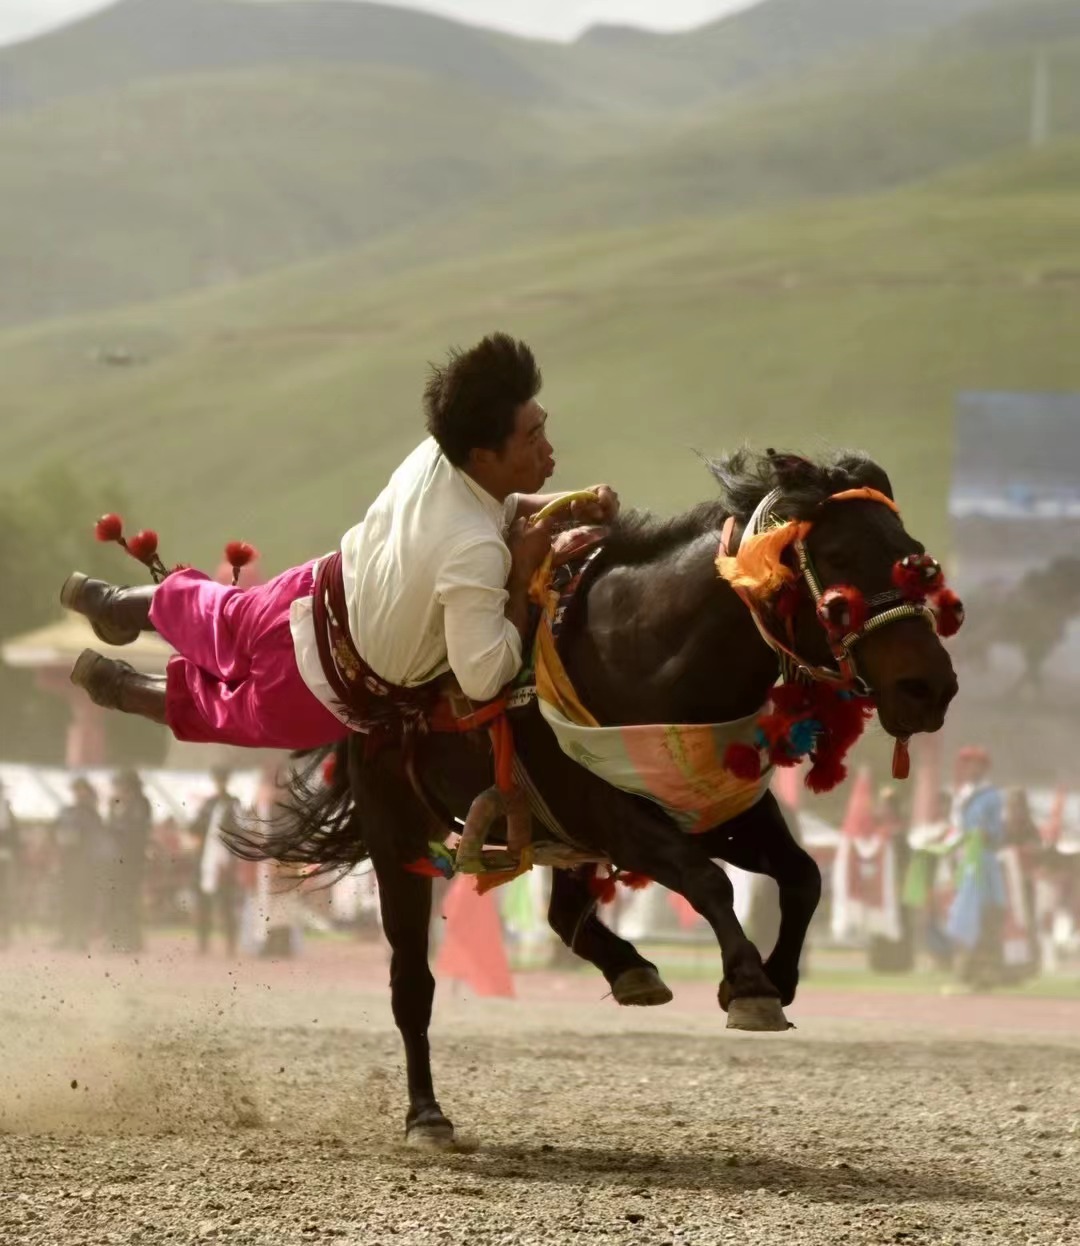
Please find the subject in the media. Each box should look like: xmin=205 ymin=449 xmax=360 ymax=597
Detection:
xmin=435 ymin=541 xmax=522 ymax=700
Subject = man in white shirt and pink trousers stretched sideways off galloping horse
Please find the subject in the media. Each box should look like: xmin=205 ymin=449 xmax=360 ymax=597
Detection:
xmin=61 ymin=334 xmax=618 ymax=749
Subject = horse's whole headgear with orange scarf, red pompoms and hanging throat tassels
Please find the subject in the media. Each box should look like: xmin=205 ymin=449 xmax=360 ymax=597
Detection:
xmin=716 ymin=488 xmax=964 ymax=791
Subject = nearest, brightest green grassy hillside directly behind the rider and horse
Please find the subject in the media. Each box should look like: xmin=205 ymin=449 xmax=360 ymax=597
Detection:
xmin=0 ymin=136 xmax=1080 ymax=567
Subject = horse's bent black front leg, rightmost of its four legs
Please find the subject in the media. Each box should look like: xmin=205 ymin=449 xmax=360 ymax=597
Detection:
xmin=701 ymin=792 xmax=821 ymax=1007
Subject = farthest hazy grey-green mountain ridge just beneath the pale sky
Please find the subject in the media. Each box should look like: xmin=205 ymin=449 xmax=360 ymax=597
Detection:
xmin=0 ymin=0 xmax=1021 ymax=112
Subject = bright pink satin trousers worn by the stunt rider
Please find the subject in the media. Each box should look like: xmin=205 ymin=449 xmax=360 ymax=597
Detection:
xmin=149 ymin=562 xmax=349 ymax=749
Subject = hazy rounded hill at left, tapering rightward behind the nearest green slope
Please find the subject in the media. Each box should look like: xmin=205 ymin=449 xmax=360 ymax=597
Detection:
xmin=0 ymin=69 xmax=642 ymax=323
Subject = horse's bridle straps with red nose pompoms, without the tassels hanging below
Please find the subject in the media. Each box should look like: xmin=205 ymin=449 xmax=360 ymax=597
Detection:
xmin=718 ymin=488 xmax=963 ymax=698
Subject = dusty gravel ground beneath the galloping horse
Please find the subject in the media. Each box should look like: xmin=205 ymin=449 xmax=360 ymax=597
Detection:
xmin=0 ymin=947 xmax=1080 ymax=1246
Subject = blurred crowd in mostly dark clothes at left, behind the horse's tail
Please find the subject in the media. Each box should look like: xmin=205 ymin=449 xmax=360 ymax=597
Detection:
xmin=0 ymin=769 xmax=381 ymax=957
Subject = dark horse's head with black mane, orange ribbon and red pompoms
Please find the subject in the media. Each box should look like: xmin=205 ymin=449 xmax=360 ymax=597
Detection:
xmin=714 ymin=451 xmax=962 ymax=739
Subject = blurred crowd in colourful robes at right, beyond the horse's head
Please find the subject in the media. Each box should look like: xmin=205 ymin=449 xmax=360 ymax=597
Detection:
xmin=828 ymin=748 xmax=1080 ymax=988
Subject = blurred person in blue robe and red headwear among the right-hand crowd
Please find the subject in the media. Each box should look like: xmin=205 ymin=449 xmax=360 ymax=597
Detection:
xmin=945 ymin=748 xmax=1007 ymax=988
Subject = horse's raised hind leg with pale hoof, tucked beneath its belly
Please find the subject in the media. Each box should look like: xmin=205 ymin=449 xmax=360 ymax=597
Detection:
xmin=548 ymin=870 xmax=671 ymax=1006
